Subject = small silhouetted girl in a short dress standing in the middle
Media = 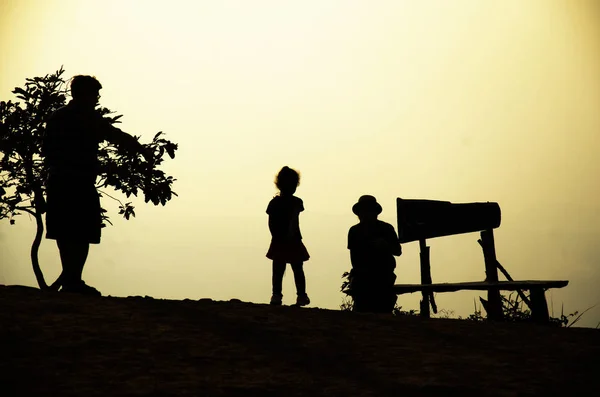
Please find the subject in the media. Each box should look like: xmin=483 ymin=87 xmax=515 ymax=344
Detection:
xmin=267 ymin=166 xmax=310 ymax=306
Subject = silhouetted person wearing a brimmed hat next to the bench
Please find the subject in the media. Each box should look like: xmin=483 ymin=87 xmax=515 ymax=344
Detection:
xmin=348 ymin=195 xmax=402 ymax=313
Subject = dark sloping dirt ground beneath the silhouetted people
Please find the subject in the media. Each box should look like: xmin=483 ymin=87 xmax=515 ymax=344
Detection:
xmin=0 ymin=286 xmax=600 ymax=397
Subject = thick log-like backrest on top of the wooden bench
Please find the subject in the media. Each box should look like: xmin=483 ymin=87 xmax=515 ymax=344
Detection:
xmin=396 ymin=198 xmax=501 ymax=243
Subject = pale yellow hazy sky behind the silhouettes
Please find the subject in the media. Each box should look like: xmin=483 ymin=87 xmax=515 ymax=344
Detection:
xmin=0 ymin=0 xmax=600 ymax=326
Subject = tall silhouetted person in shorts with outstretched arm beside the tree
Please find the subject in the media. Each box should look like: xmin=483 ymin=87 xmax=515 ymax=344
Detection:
xmin=42 ymin=75 xmax=151 ymax=296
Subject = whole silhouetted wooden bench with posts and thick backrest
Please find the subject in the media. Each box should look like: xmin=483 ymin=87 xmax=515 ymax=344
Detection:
xmin=394 ymin=198 xmax=569 ymax=323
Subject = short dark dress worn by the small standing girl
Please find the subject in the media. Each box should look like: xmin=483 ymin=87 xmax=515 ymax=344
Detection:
xmin=267 ymin=196 xmax=310 ymax=263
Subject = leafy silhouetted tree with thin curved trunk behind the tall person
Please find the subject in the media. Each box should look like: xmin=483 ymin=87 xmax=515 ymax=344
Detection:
xmin=0 ymin=67 xmax=177 ymax=289
